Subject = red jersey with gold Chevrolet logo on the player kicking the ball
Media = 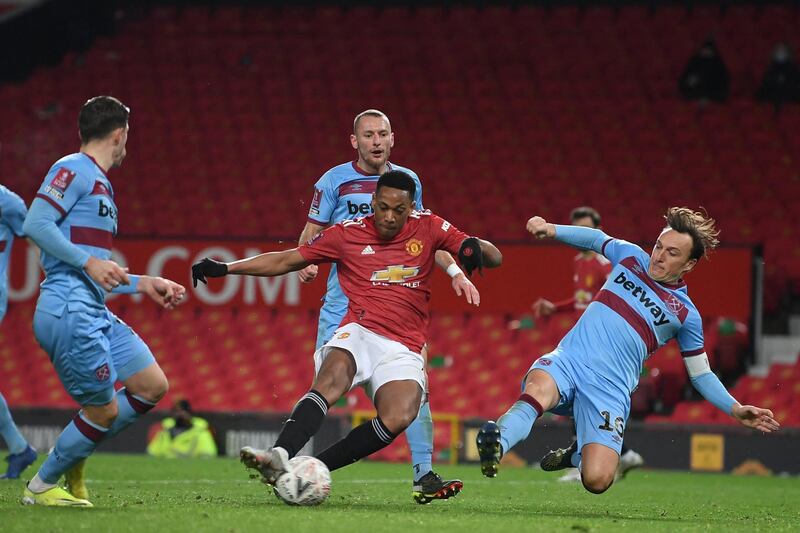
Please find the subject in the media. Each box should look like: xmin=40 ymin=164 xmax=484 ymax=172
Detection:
xmin=298 ymin=211 xmax=468 ymax=352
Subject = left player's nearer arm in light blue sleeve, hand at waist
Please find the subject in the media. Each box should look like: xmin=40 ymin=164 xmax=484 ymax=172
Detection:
xmin=22 ymin=193 xmax=130 ymax=291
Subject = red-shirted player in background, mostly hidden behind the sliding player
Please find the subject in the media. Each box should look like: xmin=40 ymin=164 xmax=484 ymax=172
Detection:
xmin=533 ymin=206 xmax=644 ymax=481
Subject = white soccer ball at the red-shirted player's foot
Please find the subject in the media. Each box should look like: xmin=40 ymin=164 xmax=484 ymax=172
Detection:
xmin=273 ymin=456 xmax=331 ymax=505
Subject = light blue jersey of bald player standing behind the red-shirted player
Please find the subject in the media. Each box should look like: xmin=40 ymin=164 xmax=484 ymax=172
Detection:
xmin=308 ymin=161 xmax=424 ymax=347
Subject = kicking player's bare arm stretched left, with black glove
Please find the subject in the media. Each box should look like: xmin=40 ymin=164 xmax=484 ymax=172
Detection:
xmin=192 ymin=248 xmax=310 ymax=287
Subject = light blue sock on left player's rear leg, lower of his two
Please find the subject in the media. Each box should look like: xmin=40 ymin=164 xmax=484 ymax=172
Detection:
xmin=39 ymin=411 xmax=108 ymax=484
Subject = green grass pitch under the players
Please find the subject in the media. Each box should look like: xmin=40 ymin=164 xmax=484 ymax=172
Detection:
xmin=0 ymin=454 xmax=800 ymax=533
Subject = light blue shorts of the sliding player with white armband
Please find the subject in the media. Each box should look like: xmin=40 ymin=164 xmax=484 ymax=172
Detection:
xmin=528 ymin=352 xmax=631 ymax=454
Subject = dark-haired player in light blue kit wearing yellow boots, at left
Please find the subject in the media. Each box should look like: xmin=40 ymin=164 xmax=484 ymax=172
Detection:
xmin=22 ymin=96 xmax=185 ymax=507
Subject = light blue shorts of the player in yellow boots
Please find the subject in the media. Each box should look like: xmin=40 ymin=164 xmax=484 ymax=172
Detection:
xmin=33 ymin=302 xmax=155 ymax=405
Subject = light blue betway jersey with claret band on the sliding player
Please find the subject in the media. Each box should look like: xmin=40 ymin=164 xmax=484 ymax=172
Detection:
xmin=556 ymin=226 xmax=704 ymax=392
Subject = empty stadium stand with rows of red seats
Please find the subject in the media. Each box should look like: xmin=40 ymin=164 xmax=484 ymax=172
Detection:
xmin=0 ymin=5 xmax=800 ymax=425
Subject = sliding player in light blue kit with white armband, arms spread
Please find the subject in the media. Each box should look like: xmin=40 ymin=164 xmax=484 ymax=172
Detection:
xmin=477 ymin=207 xmax=780 ymax=494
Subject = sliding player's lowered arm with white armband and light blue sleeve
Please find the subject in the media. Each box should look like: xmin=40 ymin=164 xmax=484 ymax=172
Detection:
xmin=683 ymin=352 xmax=780 ymax=433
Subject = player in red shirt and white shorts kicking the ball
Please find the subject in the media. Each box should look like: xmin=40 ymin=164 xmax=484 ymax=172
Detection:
xmin=192 ymin=170 xmax=502 ymax=490
